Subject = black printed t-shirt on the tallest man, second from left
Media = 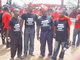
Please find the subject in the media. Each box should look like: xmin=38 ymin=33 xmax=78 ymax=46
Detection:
xmin=21 ymin=13 xmax=38 ymax=28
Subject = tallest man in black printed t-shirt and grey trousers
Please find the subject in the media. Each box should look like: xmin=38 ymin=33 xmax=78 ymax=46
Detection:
xmin=21 ymin=5 xmax=37 ymax=57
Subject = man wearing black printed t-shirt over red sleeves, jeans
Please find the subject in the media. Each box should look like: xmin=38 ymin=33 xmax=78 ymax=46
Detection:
xmin=52 ymin=10 xmax=71 ymax=60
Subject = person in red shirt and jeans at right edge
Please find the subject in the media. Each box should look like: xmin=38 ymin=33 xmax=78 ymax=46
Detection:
xmin=72 ymin=9 xmax=80 ymax=46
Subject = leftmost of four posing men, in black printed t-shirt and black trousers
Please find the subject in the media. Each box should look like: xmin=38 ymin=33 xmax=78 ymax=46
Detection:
xmin=9 ymin=8 xmax=22 ymax=60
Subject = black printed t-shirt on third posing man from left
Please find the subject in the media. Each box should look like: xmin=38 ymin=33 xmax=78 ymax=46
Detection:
xmin=38 ymin=16 xmax=53 ymax=31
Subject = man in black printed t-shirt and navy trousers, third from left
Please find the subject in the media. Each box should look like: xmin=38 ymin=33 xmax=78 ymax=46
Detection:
xmin=37 ymin=10 xmax=53 ymax=58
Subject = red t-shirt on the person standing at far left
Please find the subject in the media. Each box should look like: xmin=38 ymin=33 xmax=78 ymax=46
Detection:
xmin=2 ymin=11 xmax=11 ymax=29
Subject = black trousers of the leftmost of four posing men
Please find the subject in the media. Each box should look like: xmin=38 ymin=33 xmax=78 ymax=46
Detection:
xmin=10 ymin=33 xmax=22 ymax=58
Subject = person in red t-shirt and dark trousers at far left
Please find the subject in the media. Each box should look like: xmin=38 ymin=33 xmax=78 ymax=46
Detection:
xmin=2 ymin=7 xmax=11 ymax=48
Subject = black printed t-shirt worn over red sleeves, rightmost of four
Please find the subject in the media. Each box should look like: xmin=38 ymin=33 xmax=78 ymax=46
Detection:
xmin=54 ymin=20 xmax=69 ymax=42
